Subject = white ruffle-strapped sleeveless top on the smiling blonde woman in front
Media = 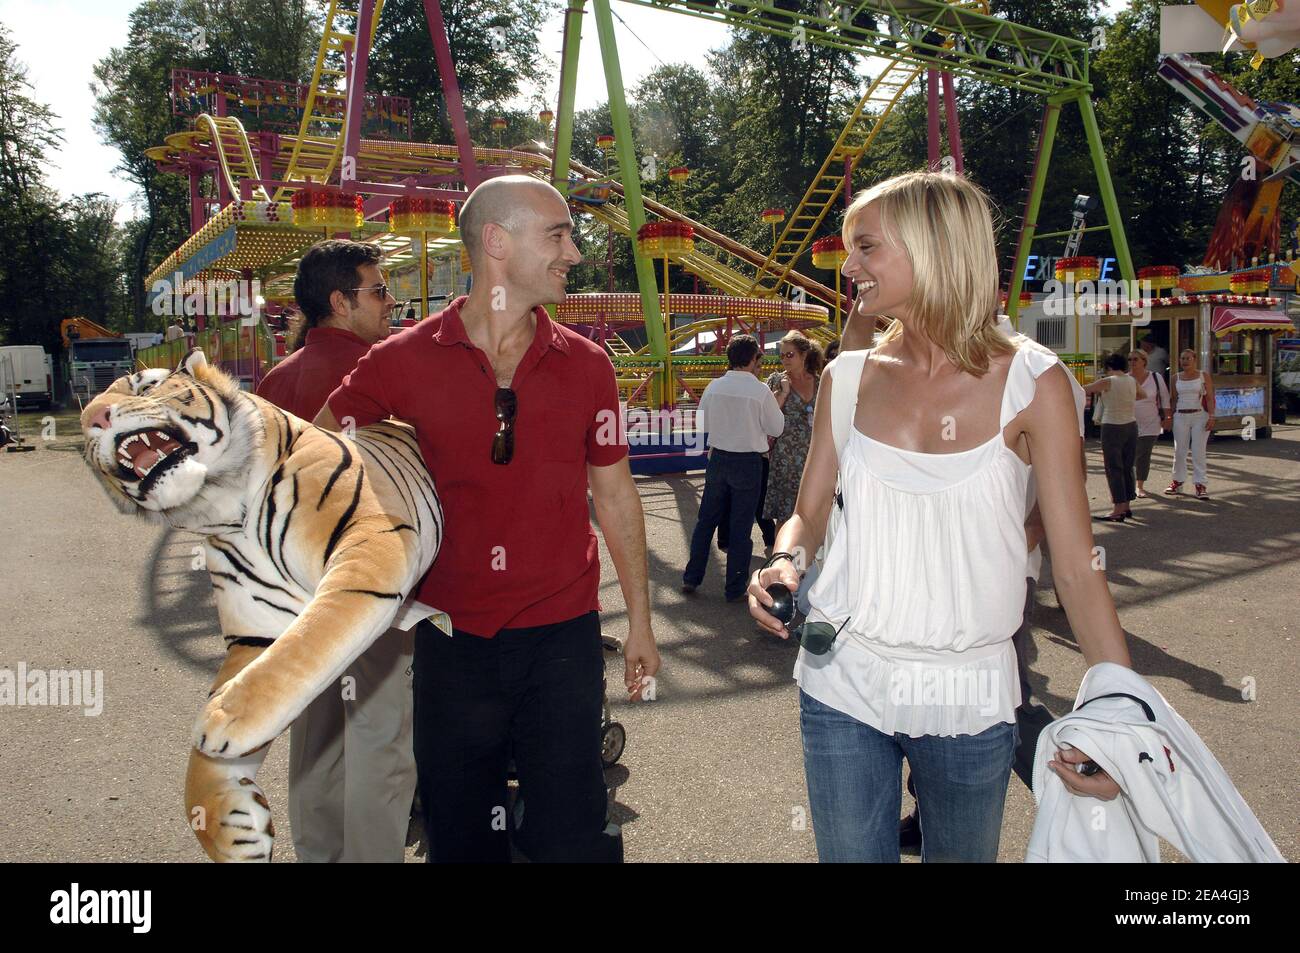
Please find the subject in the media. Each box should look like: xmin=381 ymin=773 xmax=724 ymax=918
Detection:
xmin=794 ymin=343 xmax=1060 ymax=737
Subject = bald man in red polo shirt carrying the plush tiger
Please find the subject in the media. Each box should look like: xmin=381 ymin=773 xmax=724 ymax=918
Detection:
xmin=316 ymin=176 xmax=659 ymax=862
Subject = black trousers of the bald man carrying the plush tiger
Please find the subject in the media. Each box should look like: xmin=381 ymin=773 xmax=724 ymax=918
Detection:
xmin=413 ymin=612 xmax=623 ymax=863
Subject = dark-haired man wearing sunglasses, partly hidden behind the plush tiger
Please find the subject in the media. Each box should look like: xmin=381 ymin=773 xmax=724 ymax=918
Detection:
xmin=257 ymin=241 xmax=416 ymax=863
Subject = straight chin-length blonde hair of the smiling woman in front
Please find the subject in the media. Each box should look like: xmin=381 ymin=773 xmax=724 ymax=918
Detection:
xmin=841 ymin=172 xmax=1014 ymax=377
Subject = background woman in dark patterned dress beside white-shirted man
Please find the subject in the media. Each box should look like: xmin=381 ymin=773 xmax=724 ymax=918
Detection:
xmin=763 ymin=330 xmax=822 ymax=529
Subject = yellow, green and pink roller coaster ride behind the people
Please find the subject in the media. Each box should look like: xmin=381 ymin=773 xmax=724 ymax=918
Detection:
xmin=140 ymin=0 xmax=1295 ymax=449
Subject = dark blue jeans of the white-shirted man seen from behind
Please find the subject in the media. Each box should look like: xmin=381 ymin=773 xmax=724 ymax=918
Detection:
xmin=681 ymin=450 xmax=763 ymax=599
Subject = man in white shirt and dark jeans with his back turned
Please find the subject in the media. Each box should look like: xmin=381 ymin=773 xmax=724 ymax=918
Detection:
xmin=681 ymin=334 xmax=785 ymax=602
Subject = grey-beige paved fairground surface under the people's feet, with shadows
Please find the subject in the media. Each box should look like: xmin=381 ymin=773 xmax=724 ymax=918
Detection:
xmin=0 ymin=416 xmax=1300 ymax=861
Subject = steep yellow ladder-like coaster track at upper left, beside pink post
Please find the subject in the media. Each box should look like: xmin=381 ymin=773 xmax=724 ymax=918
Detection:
xmin=274 ymin=0 xmax=384 ymax=202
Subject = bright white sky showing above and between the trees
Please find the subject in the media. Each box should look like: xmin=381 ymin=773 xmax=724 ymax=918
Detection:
xmin=0 ymin=0 xmax=1125 ymax=221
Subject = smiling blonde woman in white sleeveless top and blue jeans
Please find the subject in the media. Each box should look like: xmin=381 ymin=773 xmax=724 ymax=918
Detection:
xmin=749 ymin=173 xmax=1130 ymax=862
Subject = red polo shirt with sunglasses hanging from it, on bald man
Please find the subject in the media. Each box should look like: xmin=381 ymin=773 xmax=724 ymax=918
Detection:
xmin=329 ymin=298 xmax=628 ymax=638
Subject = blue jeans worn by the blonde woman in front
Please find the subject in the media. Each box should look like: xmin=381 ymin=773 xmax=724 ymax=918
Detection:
xmin=800 ymin=692 xmax=1017 ymax=863
